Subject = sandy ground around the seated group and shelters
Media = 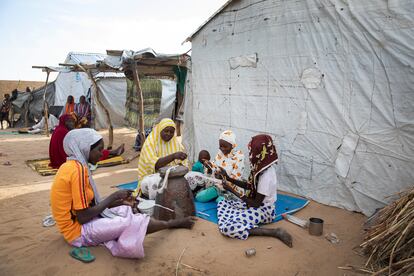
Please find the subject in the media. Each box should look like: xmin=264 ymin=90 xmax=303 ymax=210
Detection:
xmin=0 ymin=129 xmax=365 ymax=276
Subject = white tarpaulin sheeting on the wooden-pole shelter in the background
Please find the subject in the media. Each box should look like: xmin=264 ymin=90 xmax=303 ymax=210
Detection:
xmin=54 ymin=52 xmax=177 ymax=128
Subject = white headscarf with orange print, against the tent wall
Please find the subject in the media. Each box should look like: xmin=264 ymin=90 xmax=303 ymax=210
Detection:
xmin=214 ymin=130 xmax=244 ymax=179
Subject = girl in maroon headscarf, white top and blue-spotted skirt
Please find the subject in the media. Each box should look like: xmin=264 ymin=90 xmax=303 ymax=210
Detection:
xmin=217 ymin=134 xmax=292 ymax=247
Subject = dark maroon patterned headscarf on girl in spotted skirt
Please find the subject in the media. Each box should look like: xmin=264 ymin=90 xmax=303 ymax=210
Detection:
xmin=248 ymin=134 xmax=278 ymax=197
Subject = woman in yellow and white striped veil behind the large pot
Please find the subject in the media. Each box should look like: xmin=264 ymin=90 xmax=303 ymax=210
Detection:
xmin=135 ymin=119 xmax=188 ymax=199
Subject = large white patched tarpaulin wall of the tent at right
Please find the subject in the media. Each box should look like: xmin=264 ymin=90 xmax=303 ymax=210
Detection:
xmin=184 ymin=0 xmax=414 ymax=215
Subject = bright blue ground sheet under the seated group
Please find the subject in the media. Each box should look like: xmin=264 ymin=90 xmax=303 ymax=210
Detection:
xmin=117 ymin=181 xmax=309 ymax=224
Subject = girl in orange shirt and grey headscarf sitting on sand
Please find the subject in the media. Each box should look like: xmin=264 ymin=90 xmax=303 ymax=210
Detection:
xmin=50 ymin=128 xmax=194 ymax=258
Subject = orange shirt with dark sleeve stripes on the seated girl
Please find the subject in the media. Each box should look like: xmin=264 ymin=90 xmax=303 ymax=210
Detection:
xmin=50 ymin=160 xmax=94 ymax=242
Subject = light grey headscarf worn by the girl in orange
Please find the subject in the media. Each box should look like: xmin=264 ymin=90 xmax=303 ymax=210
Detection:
xmin=63 ymin=128 xmax=102 ymax=203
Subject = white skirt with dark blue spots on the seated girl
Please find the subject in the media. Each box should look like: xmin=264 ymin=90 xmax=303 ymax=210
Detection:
xmin=217 ymin=199 xmax=276 ymax=240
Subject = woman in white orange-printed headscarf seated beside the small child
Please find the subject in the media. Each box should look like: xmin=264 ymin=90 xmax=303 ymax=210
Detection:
xmin=185 ymin=130 xmax=244 ymax=202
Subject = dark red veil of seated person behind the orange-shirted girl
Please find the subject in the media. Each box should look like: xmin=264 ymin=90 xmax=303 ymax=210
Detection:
xmin=49 ymin=114 xmax=72 ymax=169
